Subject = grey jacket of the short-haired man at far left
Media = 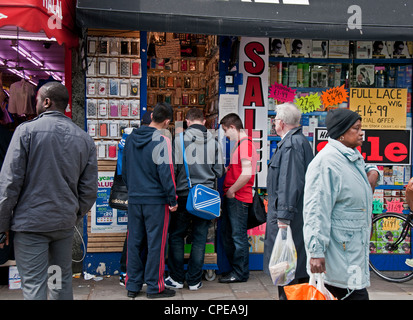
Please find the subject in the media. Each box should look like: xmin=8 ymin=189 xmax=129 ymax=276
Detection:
xmin=0 ymin=111 xmax=98 ymax=232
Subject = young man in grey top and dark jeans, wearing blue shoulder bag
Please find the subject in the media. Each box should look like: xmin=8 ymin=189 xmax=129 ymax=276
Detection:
xmin=165 ymin=108 xmax=224 ymax=290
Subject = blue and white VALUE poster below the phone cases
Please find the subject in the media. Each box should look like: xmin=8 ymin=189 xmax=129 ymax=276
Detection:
xmin=91 ymin=171 xmax=128 ymax=233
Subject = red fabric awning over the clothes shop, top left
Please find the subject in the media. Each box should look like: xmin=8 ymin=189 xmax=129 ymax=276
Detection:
xmin=0 ymin=0 xmax=79 ymax=48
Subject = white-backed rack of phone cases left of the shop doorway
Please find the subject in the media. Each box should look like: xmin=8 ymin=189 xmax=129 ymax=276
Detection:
xmin=86 ymin=33 xmax=142 ymax=160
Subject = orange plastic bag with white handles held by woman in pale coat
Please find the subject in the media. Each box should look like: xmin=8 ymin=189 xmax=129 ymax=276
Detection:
xmin=284 ymin=274 xmax=337 ymax=300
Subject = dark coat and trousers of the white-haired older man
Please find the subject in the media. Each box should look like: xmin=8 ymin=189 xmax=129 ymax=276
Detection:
xmin=264 ymin=127 xmax=313 ymax=279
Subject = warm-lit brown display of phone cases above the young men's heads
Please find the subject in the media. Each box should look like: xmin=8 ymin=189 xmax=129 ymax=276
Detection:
xmin=147 ymin=33 xmax=219 ymax=132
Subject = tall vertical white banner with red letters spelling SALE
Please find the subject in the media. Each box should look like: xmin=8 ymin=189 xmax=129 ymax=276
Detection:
xmin=238 ymin=37 xmax=269 ymax=187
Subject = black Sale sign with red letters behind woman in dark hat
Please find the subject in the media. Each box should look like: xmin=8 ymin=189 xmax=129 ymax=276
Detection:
xmin=313 ymin=128 xmax=411 ymax=165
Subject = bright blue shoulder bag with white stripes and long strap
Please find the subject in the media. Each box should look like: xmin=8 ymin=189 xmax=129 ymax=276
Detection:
xmin=180 ymin=133 xmax=221 ymax=220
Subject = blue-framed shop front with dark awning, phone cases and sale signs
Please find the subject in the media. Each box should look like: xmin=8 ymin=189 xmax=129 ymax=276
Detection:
xmin=77 ymin=0 xmax=413 ymax=274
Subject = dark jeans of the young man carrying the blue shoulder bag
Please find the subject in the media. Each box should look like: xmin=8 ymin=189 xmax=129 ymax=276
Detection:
xmin=167 ymin=196 xmax=211 ymax=286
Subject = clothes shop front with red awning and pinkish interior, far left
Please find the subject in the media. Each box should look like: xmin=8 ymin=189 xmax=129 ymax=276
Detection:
xmin=0 ymin=0 xmax=79 ymax=284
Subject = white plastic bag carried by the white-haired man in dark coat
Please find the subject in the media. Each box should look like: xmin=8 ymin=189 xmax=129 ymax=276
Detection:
xmin=268 ymin=226 xmax=297 ymax=286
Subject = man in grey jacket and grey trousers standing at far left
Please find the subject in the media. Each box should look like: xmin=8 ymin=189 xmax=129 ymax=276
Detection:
xmin=0 ymin=82 xmax=98 ymax=300
